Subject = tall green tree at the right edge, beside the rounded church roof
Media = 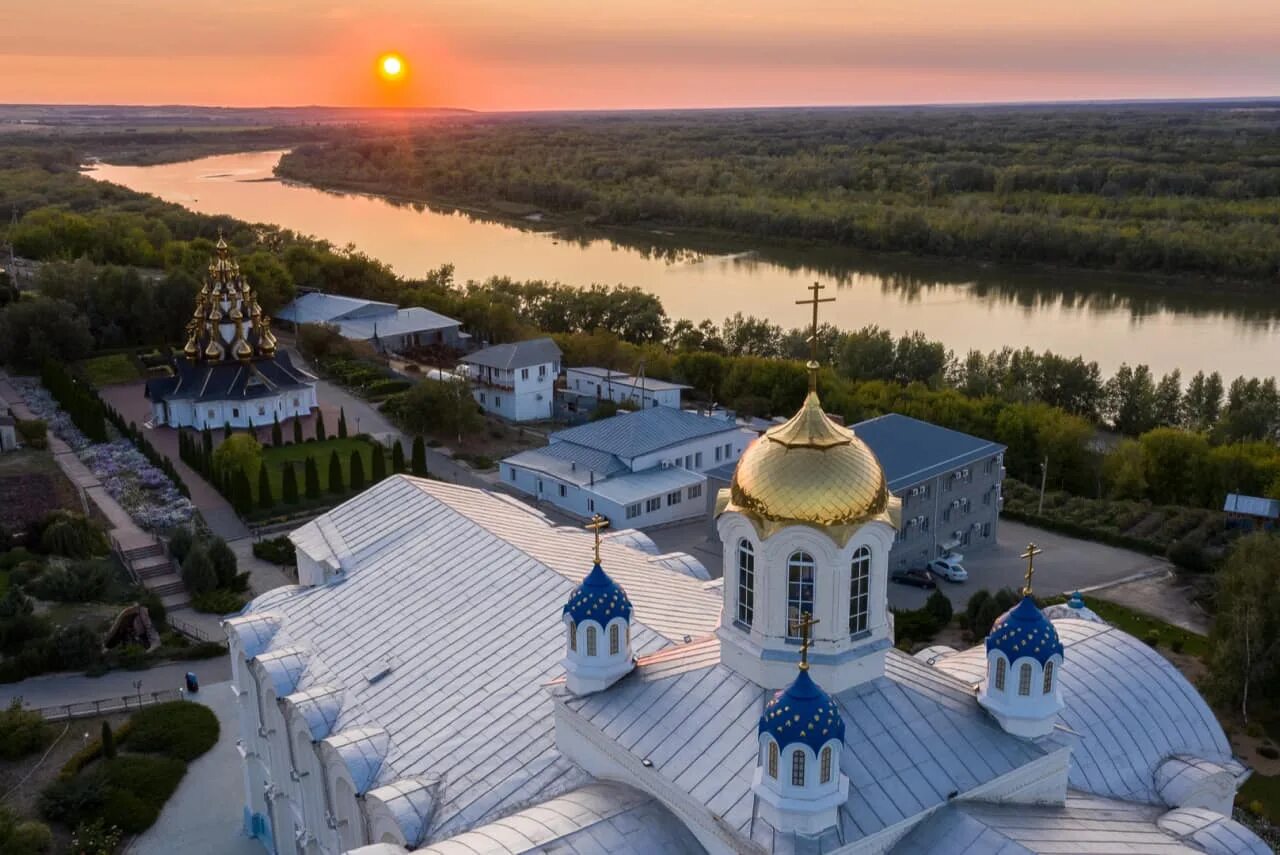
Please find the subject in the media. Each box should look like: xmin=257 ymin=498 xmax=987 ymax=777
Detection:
xmin=1210 ymin=532 xmax=1280 ymax=722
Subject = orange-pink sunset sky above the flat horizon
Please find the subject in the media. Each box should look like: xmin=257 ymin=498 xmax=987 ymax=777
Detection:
xmin=0 ymin=0 xmax=1280 ymax=110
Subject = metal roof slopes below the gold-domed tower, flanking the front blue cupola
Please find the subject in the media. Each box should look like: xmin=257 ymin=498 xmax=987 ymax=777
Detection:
xmin=564 ymin=637 xmax=1056 ymax=851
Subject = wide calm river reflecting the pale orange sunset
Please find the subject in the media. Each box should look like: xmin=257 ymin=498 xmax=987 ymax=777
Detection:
xmin=90 ymin=151 xmax=1280 ymax=380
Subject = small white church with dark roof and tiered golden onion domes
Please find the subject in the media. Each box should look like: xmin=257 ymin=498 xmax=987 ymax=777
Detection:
xmin=146 ymin=237 xmax=317 ymax=430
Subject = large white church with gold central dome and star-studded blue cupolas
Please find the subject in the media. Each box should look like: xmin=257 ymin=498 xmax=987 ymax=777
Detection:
xmin=225 ymin=292 xmax=1268 ymax=855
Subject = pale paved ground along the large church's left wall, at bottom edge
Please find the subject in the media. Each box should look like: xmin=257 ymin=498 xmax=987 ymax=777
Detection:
xmin=124 ymin=682 xmax=262 ymax=855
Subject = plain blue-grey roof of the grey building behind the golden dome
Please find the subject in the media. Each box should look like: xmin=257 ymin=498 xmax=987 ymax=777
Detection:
xmin=852 ymin=412 xmax=1005 ymax=490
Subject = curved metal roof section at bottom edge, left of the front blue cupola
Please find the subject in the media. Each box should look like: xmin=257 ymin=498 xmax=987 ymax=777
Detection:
xmin=416 ymin=782 xmax=705 ymax=855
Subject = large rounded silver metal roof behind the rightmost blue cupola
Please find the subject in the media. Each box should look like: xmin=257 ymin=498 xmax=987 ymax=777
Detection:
xmin=934 ymin=619 xmax=1235 ymax=804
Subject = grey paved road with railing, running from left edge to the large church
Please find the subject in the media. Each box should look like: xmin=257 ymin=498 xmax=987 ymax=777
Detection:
xmin=0 ymin=657 xmax=232 ymax=707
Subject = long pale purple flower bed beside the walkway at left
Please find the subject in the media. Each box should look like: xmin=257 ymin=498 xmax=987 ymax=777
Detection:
xmin=13 ymin=378 xmax=196 ymax=531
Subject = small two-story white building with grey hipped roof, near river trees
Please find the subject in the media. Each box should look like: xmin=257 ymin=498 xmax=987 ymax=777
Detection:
xmin=461 ymin=338 xmax=561 ymax=421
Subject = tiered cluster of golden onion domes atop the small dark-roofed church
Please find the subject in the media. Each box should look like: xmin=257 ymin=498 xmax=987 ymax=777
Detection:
xmin=183 ymin=236 xmax=276 ymax=362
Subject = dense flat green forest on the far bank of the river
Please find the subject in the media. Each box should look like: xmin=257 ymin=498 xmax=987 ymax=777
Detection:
xmin=279 ymin=104 xmax=1280 ymax=283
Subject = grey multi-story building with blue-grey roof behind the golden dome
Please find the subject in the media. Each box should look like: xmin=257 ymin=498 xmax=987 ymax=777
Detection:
xmin=708 ymin=412 xmax=1005 ymax=570
